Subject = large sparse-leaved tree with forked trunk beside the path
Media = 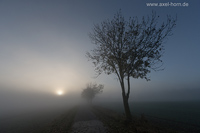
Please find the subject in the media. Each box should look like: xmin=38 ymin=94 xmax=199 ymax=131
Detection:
xmin=86 ymin=11 xmax=176 ymax=121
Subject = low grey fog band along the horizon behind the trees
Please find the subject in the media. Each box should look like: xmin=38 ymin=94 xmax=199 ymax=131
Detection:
xmin=0 ymin=86 xmax=200 ymax=117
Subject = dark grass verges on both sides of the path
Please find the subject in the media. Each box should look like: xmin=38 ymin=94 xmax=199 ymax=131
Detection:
xmin=3 ymin=106 xmax=190 ymax=133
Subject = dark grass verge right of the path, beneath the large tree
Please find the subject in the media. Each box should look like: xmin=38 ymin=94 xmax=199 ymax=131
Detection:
xmin=93 ymin=106 xmax=179 ymax=133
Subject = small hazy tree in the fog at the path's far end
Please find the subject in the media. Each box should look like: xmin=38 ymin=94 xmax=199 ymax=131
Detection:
xmin=81 ymin=83 xmax=104 ymax=104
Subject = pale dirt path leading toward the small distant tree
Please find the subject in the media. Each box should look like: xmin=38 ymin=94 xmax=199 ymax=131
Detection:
xmin=71 ymin=105 xmax=106 ymax=133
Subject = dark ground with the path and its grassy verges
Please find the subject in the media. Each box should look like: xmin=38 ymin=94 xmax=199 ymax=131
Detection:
xmin=36 ymin=105 xmax=199 ymax=133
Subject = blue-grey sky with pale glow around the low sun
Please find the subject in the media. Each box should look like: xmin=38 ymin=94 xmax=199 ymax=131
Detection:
xmin=0 ymin=0 xmax=200 ymax=111
